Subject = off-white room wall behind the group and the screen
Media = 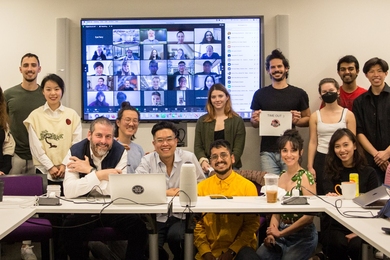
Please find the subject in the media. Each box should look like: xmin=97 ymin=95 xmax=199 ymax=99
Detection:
xmin=0 ymin=0 xmax=390 ymax=169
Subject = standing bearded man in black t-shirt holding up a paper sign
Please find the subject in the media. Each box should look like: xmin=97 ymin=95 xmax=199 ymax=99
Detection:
xmin=251 ymin=50 xmax=311 ymax=174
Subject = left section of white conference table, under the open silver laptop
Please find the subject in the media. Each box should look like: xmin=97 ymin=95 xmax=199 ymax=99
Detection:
xmin=0 ymin=196 xmax=169 ymax=260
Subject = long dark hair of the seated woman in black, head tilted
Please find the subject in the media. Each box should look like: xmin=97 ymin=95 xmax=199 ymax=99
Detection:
xmin=324 ymin=128 xmax=367 ymax=180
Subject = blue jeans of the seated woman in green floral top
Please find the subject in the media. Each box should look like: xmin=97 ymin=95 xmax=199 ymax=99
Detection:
xmin=256 ymin=223 xmax=318 ymax=260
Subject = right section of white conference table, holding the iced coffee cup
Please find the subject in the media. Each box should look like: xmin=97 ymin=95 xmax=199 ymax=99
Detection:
xmin=173 ymin=196 xmax=390 ymax=259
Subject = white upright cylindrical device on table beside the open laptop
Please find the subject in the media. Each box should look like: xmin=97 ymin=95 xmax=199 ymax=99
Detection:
xmin=179 ymin=162 xmax=198 ymax=207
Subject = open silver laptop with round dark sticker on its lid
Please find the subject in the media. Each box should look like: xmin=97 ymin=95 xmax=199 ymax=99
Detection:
xmin=109 ymin=173 xmax=167 ymax=204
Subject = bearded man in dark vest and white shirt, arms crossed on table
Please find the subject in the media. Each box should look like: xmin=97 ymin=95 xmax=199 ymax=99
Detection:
xmin=62 ymin=117 xmax=148 ymax=260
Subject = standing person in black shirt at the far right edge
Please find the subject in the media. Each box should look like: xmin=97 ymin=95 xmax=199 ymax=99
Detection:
xmin=352 ymin=57 xmax=390 ymax=183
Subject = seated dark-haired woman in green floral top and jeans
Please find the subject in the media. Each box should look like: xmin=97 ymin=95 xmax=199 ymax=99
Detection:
xmin=257 ymin=129 xmax=318 ymax=260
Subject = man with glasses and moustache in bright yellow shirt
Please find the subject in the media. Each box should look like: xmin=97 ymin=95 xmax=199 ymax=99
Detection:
xmin=194 ymin=139 xmax=260 ymax=260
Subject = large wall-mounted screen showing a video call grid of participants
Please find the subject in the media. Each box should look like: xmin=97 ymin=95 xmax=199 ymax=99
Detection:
xmin=81 ymin=17 xmax=264 ymax=121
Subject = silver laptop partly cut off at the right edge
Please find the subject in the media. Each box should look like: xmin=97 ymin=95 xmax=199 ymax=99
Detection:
xmin=353 ymin=185 xmax=389 ymax=209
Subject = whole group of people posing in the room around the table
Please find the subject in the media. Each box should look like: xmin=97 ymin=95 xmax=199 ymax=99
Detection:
xmin=0 ymin=47 xmax=390 ymax=260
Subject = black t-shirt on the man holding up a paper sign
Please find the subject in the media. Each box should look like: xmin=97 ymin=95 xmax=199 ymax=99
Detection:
xmin=251 ymin=85 xmax=309 ymax=152
